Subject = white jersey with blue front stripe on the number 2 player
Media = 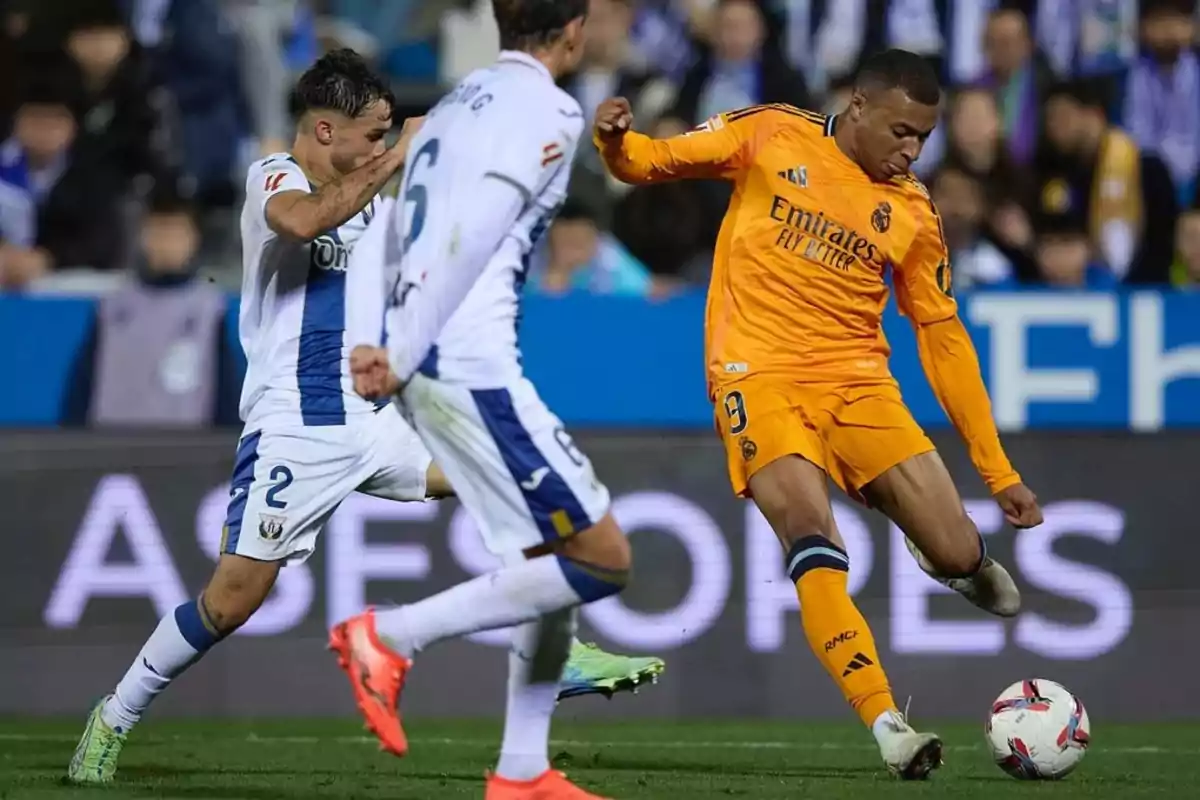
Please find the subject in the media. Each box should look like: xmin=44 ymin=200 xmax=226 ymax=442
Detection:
xmin=238 ymin=152 xmax=379 ymax=427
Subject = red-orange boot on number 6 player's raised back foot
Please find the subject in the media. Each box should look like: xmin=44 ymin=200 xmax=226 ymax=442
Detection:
xmin=329 ymin=608 xmax=413 ymax=756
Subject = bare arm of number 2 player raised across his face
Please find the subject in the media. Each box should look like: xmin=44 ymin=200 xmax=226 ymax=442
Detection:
xmin=265 ymin=118 xmax=424 ymax=241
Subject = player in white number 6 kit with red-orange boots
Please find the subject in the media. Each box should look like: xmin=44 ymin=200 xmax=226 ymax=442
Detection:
xmin=330 ymin=0 xmax=632 ymax=800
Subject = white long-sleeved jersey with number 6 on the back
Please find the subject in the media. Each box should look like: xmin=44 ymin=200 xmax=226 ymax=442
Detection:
xmin=386 ymin=52 xmax=583 ymax=387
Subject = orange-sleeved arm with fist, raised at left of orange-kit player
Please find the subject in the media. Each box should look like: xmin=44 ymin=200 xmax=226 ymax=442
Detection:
xmin=592 ymin=97 xmax=756 ymax=184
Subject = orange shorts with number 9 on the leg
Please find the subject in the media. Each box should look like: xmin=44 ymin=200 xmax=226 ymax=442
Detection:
xmin=715 ymin=375 xmax=934 ymax=503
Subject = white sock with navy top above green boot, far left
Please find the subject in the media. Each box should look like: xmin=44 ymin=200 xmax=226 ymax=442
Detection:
xmin=100 ymin=600 xmax=218 ymax=733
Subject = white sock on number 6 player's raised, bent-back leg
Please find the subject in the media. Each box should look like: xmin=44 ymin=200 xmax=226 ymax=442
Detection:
xmin=376 ymin=555 xmax=582 ymax=656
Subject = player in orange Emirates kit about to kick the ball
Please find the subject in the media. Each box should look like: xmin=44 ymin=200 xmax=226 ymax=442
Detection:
xmin=595 ymin=50 xmax=1042 ymax=778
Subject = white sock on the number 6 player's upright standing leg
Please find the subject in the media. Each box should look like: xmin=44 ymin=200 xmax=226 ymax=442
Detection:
xmin=496 ymin=614 xmax=574 ymax=781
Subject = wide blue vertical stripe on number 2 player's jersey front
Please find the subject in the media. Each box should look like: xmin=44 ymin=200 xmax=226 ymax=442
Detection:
xmin=296 ymin=230 xmax=346 ymax=426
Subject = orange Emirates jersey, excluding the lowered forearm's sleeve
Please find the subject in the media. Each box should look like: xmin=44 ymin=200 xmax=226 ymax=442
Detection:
xmin=610 ymin=106 xmax=955 ymax=390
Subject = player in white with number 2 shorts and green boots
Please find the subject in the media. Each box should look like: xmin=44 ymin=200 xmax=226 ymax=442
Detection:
xmin=67 ymin=50 xmax=662 ymax=783
